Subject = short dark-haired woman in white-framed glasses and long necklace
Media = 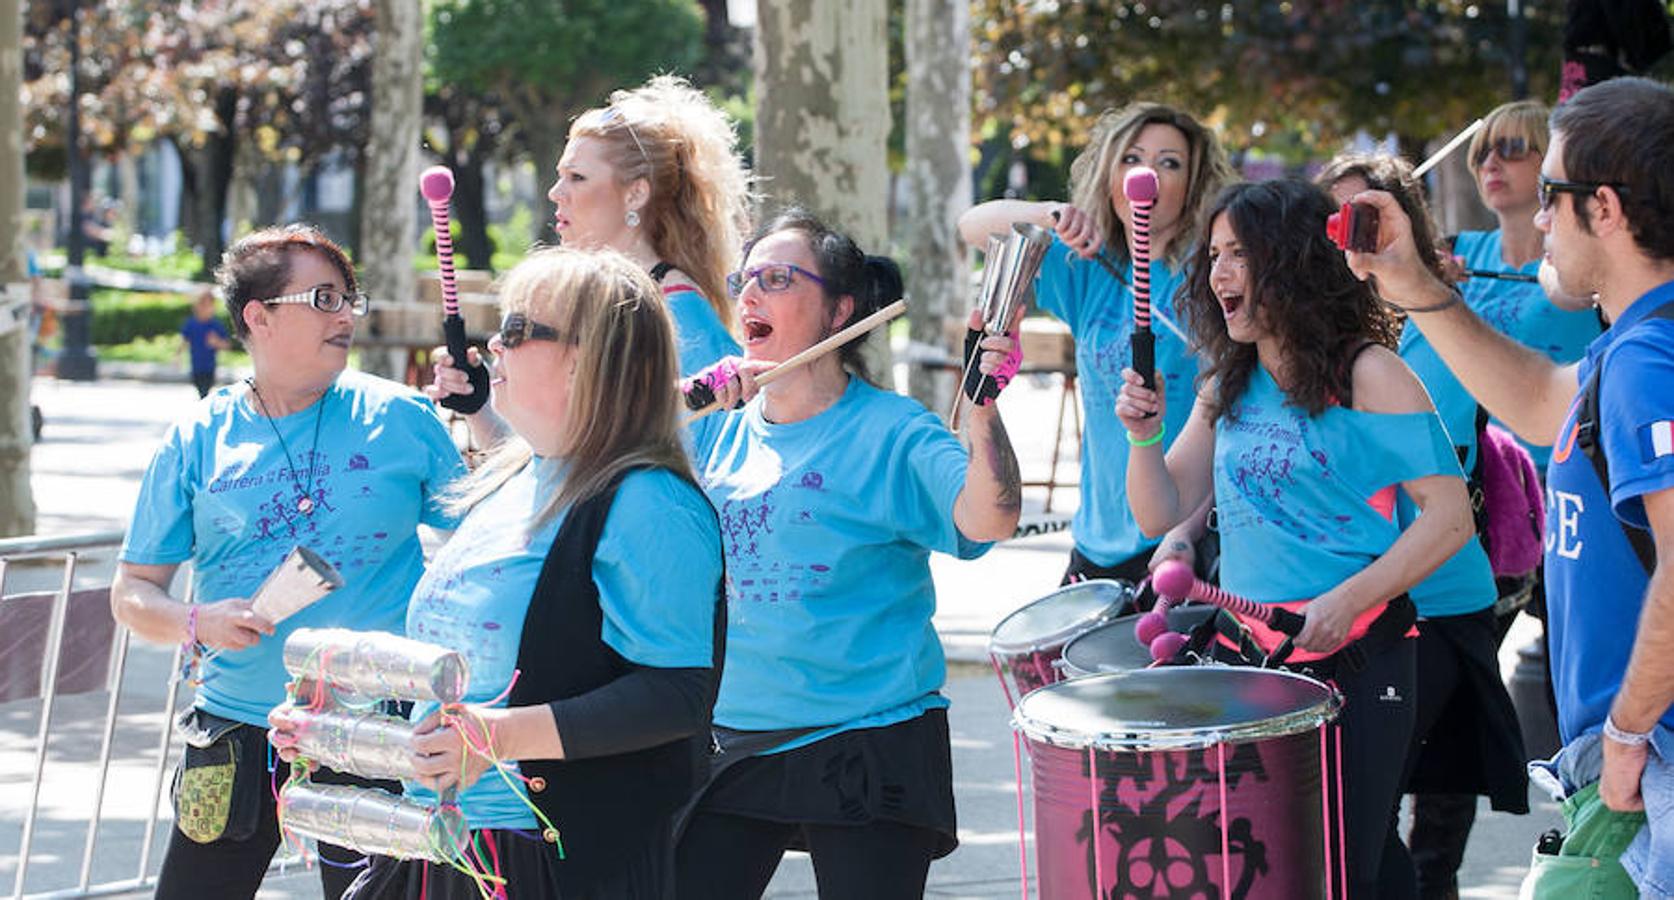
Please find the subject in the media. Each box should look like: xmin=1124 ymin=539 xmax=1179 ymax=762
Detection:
xmin=110 ymin=226 xmax=464 ymax=900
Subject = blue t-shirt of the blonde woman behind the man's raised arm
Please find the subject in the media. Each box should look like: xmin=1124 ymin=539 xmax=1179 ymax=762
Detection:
xmin=1453 ymin=229 xmax=1600 ymax=468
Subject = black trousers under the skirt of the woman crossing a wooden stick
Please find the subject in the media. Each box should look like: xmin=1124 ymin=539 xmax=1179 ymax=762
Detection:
xmin=675 ymin=810 xmax=941 ymax=900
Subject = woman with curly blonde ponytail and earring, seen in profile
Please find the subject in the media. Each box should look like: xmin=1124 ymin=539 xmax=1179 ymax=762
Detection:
xmin=546 ymin=75 xmax=750 ymax=373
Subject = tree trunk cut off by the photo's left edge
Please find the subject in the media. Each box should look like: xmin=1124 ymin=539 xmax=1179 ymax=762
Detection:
xmin=0 ymin=0 xmax=35 ymax=537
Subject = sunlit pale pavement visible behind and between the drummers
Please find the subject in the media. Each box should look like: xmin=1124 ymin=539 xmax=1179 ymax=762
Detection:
xmin=0 ymin=369 xmax=1558 ymax=900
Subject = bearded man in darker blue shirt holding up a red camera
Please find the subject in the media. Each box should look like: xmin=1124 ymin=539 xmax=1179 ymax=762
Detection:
xmin=1348 ymin=79 xmax=1674 ymax=897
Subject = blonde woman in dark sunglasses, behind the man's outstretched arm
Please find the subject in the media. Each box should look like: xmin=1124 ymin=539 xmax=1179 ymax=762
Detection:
xmin=1453 ymin=100 xmax=1602 ymax=472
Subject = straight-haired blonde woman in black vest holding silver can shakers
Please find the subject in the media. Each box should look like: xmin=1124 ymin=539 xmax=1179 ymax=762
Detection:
xmin=292 ymin=248 xmax=725 ymax=900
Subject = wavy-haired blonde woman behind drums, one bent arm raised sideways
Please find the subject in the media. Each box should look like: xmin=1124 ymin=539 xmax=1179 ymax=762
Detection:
xmin=959 ymin=104 xmax=1232 ymax=584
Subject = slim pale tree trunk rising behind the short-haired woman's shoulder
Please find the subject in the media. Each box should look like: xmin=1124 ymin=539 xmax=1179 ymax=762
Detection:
xmin=357 ymin=0 xmax=424 ymax=375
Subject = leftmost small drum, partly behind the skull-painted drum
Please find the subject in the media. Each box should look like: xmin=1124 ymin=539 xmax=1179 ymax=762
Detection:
xmin=988 ymin=579 xmax=1133 ymax=706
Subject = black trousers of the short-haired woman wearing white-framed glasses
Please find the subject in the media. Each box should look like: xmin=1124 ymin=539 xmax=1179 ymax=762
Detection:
xmin=157 ymin=724 xmax=400 ymax=900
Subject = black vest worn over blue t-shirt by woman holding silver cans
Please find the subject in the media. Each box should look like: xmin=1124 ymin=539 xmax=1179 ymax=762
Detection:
xmin=507 ymin=472 xmax=727 ymax=897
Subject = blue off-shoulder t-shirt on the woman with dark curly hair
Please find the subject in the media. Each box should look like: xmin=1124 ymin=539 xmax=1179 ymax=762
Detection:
xmin=1215 ymin=366 xmax=1465 ymax=602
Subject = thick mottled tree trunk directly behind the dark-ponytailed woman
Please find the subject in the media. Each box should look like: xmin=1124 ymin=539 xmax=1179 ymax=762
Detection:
xmin=755 ymin=0 xmax=894 ymax=378
